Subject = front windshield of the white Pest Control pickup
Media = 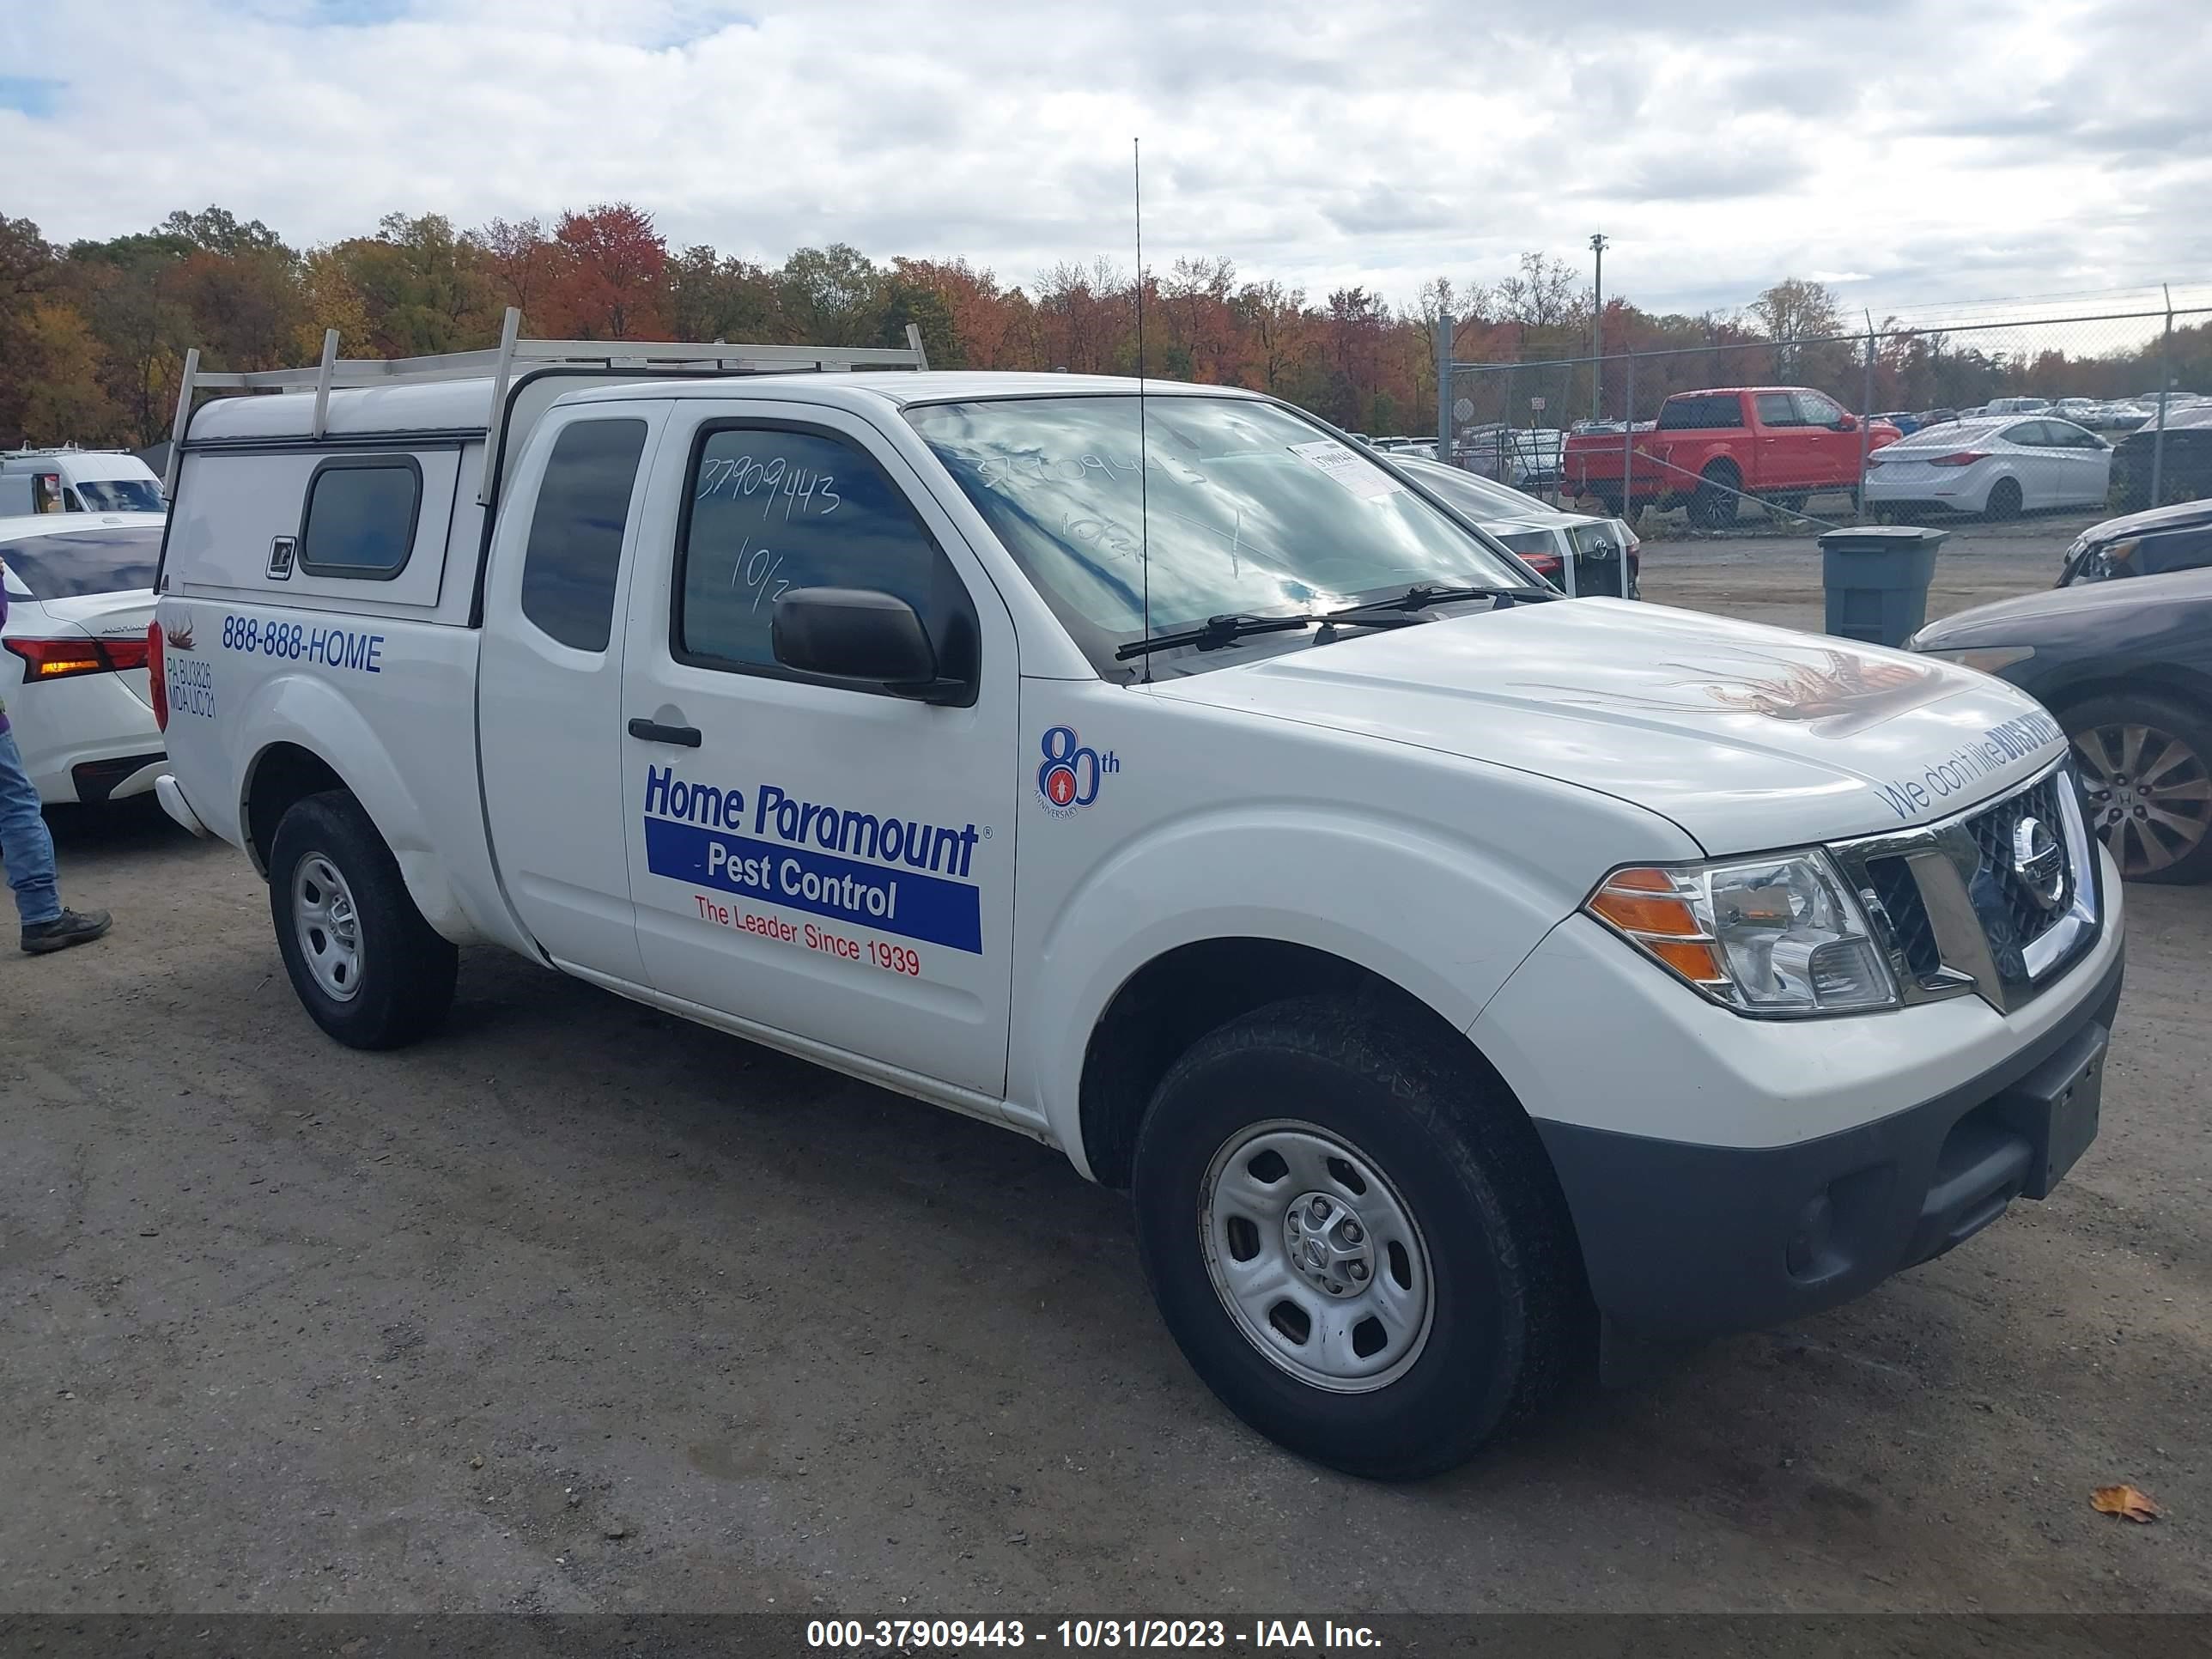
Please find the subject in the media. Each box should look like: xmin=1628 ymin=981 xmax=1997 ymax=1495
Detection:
xmin=907 ymin=394 xmax=1528 ymax=668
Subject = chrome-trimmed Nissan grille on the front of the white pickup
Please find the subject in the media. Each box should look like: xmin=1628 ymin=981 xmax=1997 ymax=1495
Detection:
xmin=1834 ymin=765 xmax=2100 ymax=1011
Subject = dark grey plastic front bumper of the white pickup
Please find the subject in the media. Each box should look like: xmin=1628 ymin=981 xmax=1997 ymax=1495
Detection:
xmin=1537 ymin=949 xmax=2126 ymax=1343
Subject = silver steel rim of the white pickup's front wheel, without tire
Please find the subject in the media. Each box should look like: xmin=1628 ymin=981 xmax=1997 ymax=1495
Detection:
xmin=1199 ymin=1119 xmax=1436 ymax=1394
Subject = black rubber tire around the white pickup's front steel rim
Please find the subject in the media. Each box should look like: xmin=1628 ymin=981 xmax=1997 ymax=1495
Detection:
xmin=1133 ymin=998 xmax=1593 ymax=1480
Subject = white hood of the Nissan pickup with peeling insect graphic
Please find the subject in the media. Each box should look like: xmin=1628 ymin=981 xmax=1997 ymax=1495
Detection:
xmin=1157 ymin=599 xmax=2066 ymax=854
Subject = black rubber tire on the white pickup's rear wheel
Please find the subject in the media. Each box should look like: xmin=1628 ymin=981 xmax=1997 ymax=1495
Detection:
xmin=270 ymin=790 xmax=460 ymax=1048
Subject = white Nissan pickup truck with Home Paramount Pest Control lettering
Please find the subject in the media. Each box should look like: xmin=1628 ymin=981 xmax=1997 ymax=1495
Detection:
xmin=150 ymin=320 xmax=2121 ymax=1478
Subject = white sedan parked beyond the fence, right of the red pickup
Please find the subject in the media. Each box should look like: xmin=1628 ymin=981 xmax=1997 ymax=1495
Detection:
xmin=1867 ymin=416 xmax=2112 ymax=520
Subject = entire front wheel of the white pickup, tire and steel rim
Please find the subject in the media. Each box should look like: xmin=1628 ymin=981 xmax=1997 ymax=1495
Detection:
xmin=1133 ymin=998 xmax=1590 ymax=1480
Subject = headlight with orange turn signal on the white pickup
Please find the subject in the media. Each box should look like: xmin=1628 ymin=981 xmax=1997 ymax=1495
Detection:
xmin=1583 ymin=852 xmax=1898 ymax=1015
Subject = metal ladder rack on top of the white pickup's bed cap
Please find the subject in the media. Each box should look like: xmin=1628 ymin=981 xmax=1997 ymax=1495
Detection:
xmin=161 ymin=305 xmax=929 ymax=504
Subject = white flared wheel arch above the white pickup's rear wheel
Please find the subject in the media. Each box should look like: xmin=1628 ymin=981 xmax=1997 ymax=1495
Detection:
xmin=239 ymin=675 xmax=480 ymax=945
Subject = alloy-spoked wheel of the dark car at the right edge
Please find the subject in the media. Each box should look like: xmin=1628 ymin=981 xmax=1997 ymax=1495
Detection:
xmin=2059 ymin=692 xmax=2212 ymax=884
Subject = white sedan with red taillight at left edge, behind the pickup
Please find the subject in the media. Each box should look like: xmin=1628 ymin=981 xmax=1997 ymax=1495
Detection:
xmin=0 ymin=514 xmax=164 ymax=805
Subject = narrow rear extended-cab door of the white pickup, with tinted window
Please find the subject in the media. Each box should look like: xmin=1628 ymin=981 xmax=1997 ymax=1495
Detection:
xmin=475 ymin=403 xmax=668 ymax=984
